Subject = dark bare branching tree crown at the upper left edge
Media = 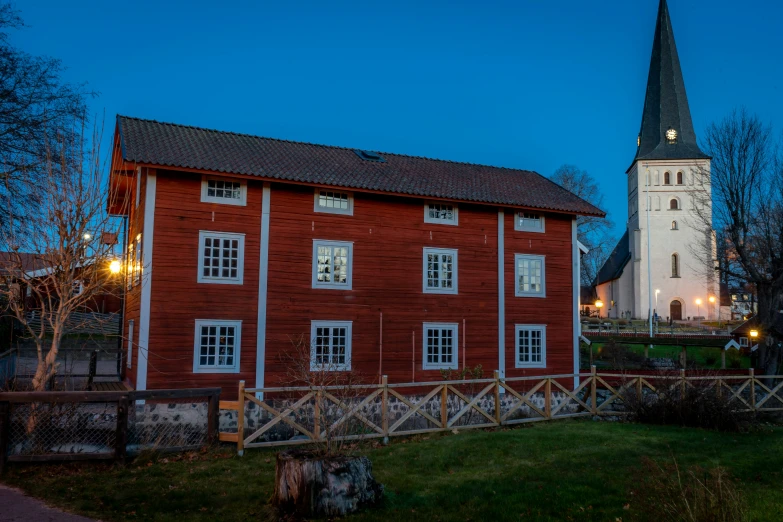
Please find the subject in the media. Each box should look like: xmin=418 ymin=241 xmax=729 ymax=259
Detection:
xmin=0 ymin=4 xmax=92 ymax=228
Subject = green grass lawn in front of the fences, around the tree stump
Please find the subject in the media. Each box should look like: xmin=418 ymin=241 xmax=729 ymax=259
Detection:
xmin=2 ymin=420 xmax=783 ymax=522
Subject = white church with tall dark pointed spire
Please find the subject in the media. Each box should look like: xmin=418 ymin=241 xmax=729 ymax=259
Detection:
xmin=596 ymin=0 xmax=719 ymax=320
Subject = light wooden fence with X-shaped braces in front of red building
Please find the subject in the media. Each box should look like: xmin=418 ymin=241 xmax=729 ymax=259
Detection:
xmin=220 ymin=366 xmax=783 ymax=455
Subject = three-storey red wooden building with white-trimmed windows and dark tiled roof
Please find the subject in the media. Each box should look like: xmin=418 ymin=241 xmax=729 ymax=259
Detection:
xmin=111 ymin=116 xmax=604 ymax=390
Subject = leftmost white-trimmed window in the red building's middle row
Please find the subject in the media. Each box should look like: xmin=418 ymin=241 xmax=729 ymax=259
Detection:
xmin=198 ymin=230 xmax=245 ymax=285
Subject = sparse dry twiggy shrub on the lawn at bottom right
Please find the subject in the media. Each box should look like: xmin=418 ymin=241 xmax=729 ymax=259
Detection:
xmin=634 ymin=458 xmax=750 ymax=522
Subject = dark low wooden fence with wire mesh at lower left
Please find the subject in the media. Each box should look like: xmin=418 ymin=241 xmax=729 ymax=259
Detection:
xmin=0 ymin=388 xmax=220 ymax=471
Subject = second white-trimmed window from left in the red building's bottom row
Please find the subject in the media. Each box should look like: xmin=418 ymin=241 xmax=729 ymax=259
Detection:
xmin=310 ymin=321 xmax=353 ymax=371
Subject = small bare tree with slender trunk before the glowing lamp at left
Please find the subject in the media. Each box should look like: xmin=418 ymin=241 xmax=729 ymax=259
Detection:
xmin=0 ymin=120 xmax=121 ymax=390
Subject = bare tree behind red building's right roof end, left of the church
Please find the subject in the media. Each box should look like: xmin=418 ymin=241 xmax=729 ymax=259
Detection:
xmin=550 ymin=165 xmax=617 ymax=284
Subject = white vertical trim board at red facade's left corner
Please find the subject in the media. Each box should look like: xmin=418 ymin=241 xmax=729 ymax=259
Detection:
xmin=136 ymin=169 xmax=157 ymax=390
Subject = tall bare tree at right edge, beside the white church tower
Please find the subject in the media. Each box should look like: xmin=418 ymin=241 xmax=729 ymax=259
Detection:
xmin=692 ymin=108 xmax=783 ymax=373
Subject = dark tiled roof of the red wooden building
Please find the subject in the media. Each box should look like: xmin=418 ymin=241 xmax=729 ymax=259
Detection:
xmin=117 ymin=116 xmax=604 ymax=216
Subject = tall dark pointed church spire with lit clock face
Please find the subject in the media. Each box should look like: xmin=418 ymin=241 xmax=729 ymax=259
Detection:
xmin=635 ymin=0 xmax=708 ymax=160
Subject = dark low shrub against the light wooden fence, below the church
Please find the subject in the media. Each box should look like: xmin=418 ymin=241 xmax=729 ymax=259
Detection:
xmin=623 ymin=374 xmax=756 ymax=432
